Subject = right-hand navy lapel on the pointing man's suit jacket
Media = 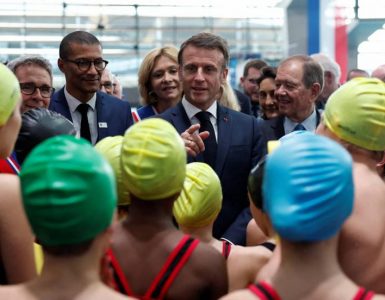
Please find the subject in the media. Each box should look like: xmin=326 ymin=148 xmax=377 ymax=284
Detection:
xmin=215 ymin=104 xmax=232 ymax=174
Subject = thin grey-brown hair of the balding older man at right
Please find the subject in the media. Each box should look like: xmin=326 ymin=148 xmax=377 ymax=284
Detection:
xmin=280 ymin=55 xmax=324 ymax=91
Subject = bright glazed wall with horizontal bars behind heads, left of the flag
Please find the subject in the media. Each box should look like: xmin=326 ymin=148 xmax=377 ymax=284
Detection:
xmin=0 ymin=0 xmax=291 ymax=91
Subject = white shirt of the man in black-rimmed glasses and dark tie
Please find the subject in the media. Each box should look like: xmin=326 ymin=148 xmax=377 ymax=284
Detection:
xmin=64 ymin=87 xmax=98 ymax=145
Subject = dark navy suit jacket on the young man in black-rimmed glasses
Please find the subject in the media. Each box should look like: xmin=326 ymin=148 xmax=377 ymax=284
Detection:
xmin=49 ymin=88 xmax=133 ymax=141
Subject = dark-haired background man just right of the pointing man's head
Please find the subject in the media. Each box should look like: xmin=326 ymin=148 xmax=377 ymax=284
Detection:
xmin=241 ymin=59 xmax=267 ymax=117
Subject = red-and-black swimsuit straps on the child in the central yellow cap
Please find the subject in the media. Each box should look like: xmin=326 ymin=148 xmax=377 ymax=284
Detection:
xmin=106 ymin=235 xmax=199 ymax=299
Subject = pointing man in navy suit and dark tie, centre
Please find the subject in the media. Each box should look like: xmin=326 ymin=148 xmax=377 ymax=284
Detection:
xmin=159 ymin=33 xmax=264 ymax=244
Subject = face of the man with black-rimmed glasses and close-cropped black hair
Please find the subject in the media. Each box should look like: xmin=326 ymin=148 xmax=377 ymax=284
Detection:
xmin=58 ymin=43 xmax=103 ymax=102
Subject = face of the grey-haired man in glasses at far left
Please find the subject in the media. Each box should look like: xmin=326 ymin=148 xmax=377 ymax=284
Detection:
xmin=15 ymin=64 xmax=52 ymax=113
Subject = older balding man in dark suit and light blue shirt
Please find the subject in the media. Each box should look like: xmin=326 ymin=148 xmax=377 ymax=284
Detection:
xmin=260 ymin=55 xmax=324 ymax=140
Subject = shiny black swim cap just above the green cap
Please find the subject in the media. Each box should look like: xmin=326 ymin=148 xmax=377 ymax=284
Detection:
xmin=15 ymin=107 xmax=76 ymax=163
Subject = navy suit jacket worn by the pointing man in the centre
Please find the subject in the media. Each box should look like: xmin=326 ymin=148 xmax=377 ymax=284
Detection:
xmin=158 ymin=102 xmax=265 ymax=244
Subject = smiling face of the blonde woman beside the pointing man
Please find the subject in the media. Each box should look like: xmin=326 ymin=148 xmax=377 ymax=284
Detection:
xmin=150 ymin=56 xmax=182 ymax=103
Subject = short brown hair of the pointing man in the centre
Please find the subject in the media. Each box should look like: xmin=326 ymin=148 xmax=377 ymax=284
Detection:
xmin=178 ymin=32 xmax=230 ymax=68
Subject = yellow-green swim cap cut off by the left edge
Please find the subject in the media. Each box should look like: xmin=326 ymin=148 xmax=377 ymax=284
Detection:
xmin=0 ymin=63 xmax=21 ymax=126
